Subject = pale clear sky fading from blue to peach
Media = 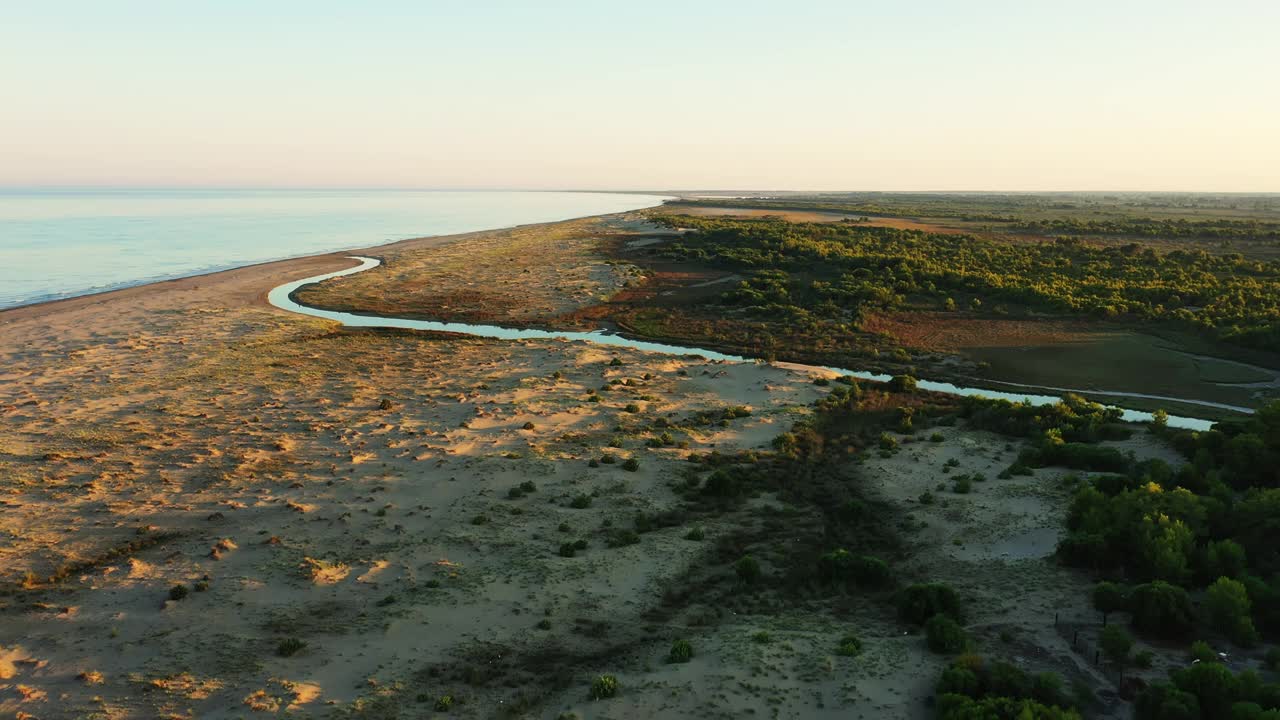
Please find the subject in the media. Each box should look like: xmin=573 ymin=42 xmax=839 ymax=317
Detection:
xmin=0 ymin=0 xmax=1280 ymax=192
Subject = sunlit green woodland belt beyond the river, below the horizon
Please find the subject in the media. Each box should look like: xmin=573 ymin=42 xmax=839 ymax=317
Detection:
xmin=662 ymin=217 xmax=1280 ymax=351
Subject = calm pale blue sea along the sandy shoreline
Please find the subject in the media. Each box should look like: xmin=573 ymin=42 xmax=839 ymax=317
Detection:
xmin=0 ymin=190 xmax=662 ymax=307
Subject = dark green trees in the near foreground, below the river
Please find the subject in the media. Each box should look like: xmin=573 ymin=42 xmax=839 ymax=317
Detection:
xmin=938 ymin=396 xmax=1280 ymax=720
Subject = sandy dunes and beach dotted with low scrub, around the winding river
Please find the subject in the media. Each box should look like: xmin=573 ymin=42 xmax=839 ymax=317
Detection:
xmin=0 ymin=214 xmax=1141 ymax=719
